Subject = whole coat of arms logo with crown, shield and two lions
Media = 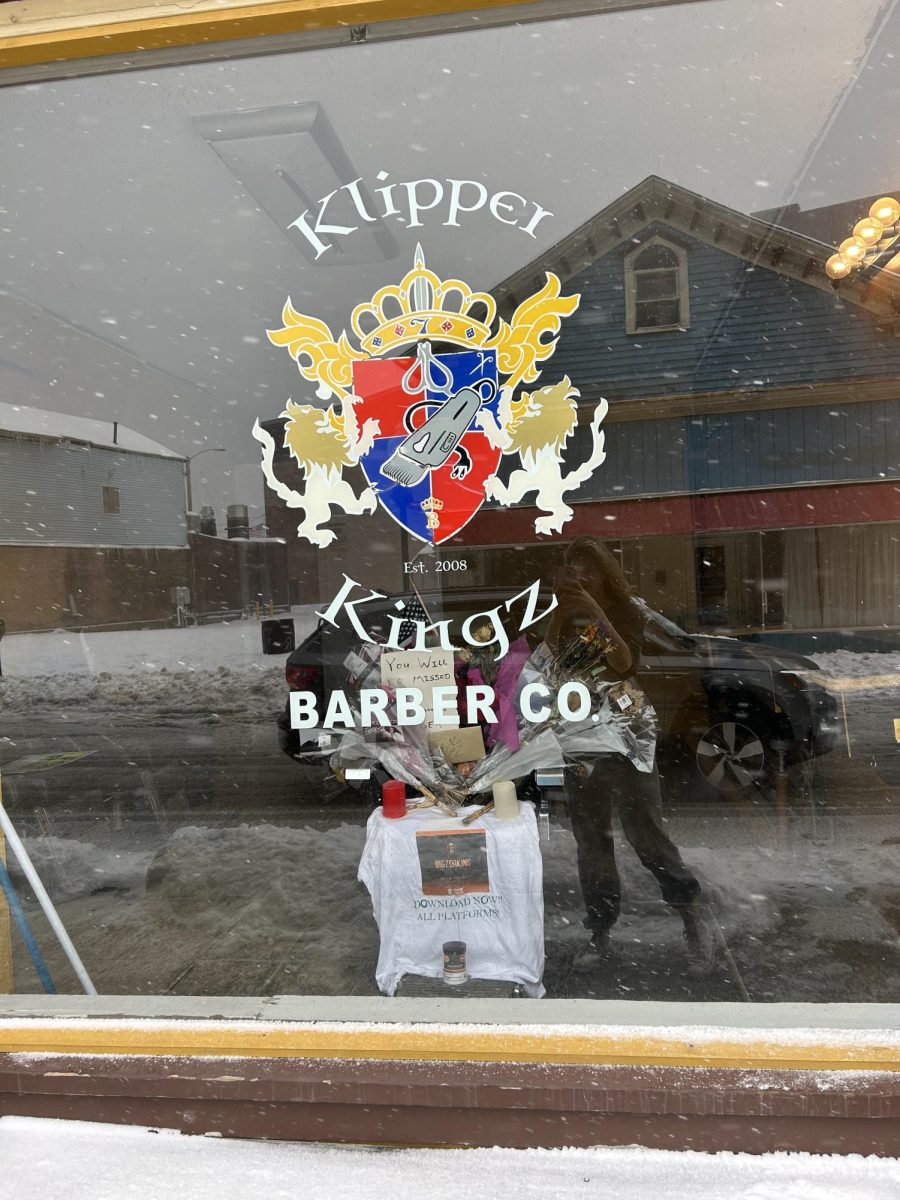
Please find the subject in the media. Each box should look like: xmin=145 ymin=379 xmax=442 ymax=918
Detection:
xmin=253 ymin=247 xmax=607 ymax=547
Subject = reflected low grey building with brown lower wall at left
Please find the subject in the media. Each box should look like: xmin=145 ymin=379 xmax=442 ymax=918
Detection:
xmin=0 ymin=403 xmax=287 ymax=634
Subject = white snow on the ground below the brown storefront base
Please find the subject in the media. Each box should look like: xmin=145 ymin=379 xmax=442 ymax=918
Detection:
xmin=0 ymin=1117 xmax=900 ymax=1200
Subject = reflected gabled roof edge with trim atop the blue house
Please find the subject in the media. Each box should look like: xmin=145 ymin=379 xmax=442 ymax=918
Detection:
xmin=491 ymin=175 xmax=900 ymax=329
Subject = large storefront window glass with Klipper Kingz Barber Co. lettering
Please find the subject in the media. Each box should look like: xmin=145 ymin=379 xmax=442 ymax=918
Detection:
xmin=0 ymin=0 xmax=900 ymax=1013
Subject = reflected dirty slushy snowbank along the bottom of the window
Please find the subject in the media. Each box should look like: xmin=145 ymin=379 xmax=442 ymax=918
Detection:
xmin=10 ymin=796 xmax=900 ymax=1001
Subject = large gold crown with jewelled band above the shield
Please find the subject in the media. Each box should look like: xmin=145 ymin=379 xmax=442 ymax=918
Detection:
xmin=350 ymin=246 xmax=497 ymax=355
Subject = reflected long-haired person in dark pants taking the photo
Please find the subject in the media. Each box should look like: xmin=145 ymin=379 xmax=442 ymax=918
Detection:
xmin=546 ymin=538 xmax=715 ymax=974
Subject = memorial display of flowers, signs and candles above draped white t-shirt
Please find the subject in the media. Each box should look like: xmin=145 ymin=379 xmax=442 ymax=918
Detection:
xmin=328 ymin=556 xmax=667 ymax=996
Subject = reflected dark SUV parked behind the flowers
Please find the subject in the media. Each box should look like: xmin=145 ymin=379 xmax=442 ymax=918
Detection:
xmin=278 ymin=590 xmax=839 ymax=793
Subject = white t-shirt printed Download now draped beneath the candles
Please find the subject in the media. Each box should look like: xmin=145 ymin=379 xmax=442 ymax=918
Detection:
xmin=359 ymin=804 xmax=544 ymax=997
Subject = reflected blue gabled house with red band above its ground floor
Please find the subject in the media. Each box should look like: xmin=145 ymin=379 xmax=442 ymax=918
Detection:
xmin=452 ymin=176 xmax=900 ymax=649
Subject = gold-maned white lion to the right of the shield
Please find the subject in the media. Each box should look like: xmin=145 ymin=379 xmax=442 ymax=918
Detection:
xmin=476 ymin=376 xmax=608 ymax=534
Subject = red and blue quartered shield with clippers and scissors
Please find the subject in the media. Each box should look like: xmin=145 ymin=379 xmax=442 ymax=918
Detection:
xmin=353 ymin=342 xmax=500 ymax=546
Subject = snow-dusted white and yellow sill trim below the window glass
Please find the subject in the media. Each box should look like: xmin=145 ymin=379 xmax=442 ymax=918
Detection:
xmin=0 ymin=996 xmax=900 ymax=1072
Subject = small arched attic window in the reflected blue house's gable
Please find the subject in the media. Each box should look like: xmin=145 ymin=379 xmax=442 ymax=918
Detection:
xmin=625 ymin=238 xmax=690 ymax=334
